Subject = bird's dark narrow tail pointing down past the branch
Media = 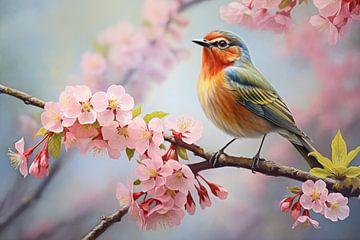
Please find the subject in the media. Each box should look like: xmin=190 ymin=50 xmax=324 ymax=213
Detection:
xmin=281 ymin=134 xmax=322 ymax=168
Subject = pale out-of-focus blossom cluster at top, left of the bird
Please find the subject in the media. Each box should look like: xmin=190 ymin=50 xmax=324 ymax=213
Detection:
xmin=80 ymin=0 xmax=188 ymax=101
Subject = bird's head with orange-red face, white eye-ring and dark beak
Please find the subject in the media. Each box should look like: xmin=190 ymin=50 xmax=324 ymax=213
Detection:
xmin=193 ymin=31 xmax=250 ymax=73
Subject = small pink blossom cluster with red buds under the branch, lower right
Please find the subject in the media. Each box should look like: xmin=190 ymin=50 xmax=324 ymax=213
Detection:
xmin=279 ymin=180 xmax=350 ymax=229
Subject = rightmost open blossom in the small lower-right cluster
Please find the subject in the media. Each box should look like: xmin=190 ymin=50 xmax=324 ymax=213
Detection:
xmin=324 ymin=193 xmax=350 ymax=222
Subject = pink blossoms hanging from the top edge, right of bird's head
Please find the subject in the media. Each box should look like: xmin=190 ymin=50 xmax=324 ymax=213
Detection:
xmin=220 ymin=0 xmax=360 ymax=44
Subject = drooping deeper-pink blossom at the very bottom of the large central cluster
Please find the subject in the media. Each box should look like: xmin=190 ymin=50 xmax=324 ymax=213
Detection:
xmin=146 ymin=204 xmax=184 ymax=230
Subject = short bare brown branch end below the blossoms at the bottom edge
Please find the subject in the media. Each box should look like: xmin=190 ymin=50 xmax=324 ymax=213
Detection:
xmin=82 ymin=207 xmax=128 ymax=240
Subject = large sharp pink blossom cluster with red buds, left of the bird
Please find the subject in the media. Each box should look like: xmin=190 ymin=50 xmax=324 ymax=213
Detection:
xmin=9 ymin=85 xmax=227 ymax=229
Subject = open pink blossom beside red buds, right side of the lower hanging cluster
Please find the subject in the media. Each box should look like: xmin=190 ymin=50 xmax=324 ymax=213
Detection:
xmin=165 ymin=160 xmax=195 ymax=194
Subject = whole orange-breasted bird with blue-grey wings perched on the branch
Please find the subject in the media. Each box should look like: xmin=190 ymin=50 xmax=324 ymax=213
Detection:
xmin=192 ymin=30 xmax=321 ymax=173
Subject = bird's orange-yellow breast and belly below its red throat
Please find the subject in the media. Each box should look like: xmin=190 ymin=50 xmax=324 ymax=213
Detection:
xmin=198 ymin=71 xmax=273 ymax=137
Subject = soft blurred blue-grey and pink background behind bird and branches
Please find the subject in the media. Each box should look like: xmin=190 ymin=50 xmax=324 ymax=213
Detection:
xmin=0 ymin=0 xmax=360 ymax=239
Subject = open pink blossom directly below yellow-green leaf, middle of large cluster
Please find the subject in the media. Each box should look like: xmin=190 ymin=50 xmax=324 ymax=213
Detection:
xmin=128 ymin=117 xmax=164 ymax=155
